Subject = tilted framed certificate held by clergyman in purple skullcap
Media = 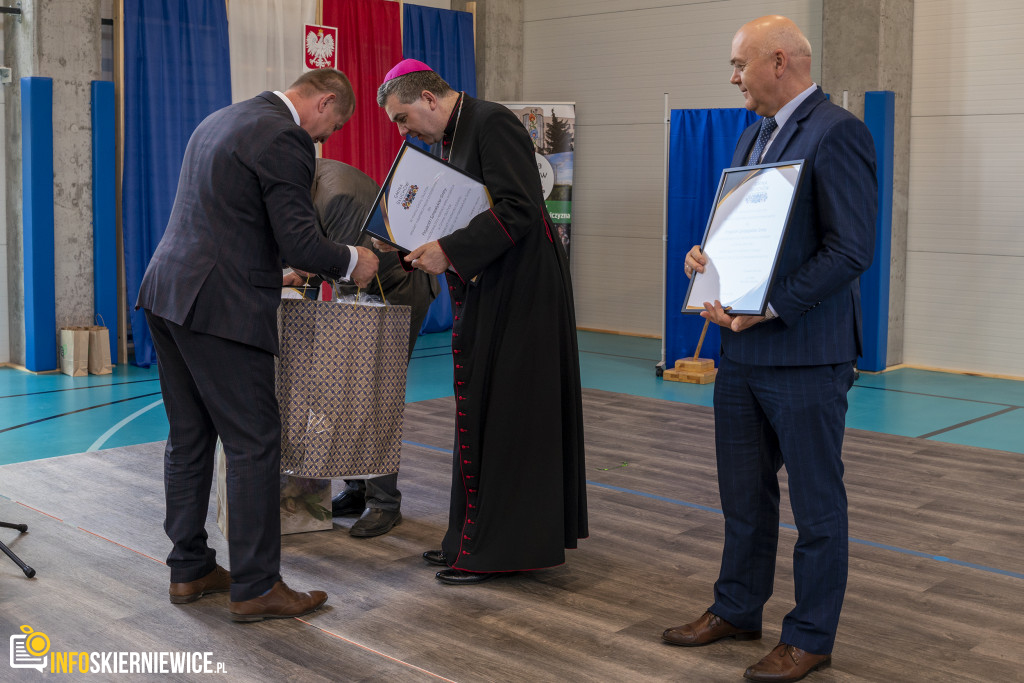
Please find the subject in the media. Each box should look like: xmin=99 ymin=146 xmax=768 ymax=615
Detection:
xmin=362 ymin=141 xmax=494 ymax=251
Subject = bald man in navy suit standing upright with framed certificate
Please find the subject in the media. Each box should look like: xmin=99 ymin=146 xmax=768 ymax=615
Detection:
xmin=663 ymin=16 xmax=878 ymax=681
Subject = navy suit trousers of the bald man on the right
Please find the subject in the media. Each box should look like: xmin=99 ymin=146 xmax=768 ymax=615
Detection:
xmin=711 ymin=356 xmax=853 ymax=654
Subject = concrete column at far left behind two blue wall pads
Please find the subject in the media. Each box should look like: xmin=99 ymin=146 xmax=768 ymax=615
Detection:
xmin=3 ymin=0 xmax=102 ymax=365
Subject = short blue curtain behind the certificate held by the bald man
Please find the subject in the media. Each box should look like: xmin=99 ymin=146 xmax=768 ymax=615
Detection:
xmin=665 ymin=109 xmax=760 ymax=368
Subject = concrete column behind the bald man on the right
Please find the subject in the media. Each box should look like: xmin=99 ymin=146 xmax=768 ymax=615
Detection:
xmin=820 ymin=0 xmax=913 ymax=366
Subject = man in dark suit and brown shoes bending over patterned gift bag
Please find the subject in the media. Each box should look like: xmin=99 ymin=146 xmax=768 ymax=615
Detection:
xmin=136 ymin=69 xmax=377 ymax=622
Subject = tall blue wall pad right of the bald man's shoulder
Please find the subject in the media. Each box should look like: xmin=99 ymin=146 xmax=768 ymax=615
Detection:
xmin=857 ymin=90 xmax=896 ymax=372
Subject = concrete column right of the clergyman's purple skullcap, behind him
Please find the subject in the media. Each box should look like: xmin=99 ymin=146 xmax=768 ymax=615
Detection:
xmin=452 ymin=0 xmax=524 ymax=101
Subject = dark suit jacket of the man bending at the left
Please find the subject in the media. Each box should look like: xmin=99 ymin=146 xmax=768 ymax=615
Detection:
xmin=136 ymin=92 xmax=350 ymax=353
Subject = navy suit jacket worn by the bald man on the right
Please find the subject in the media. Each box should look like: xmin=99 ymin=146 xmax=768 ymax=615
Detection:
xmin=722 ymin=88 xmax=878 ymax=366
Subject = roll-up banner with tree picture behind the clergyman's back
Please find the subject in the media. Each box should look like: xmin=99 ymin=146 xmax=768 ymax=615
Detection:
xmin=502 ymin=102 xmax=575 ymax=254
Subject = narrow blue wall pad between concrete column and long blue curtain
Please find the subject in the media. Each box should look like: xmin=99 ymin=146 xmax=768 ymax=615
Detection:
xmin=92 ymin=81 xmax=118 ymax=358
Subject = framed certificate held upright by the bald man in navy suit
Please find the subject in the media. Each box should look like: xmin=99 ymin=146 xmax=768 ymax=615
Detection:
xmin=683 ymin=160 xmax=804 ymax=315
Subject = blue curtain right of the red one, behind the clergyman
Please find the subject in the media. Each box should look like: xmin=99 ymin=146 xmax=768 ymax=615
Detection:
xmin=401 ymin=3 xmax=476 ymax=334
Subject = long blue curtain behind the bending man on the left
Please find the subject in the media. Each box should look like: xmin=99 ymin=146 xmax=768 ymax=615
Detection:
xmin=122 ymin=0 xmax=231 ymax=367
